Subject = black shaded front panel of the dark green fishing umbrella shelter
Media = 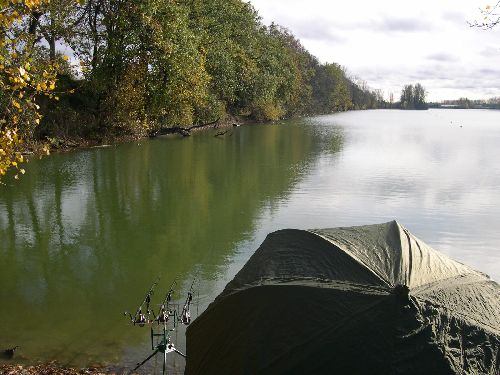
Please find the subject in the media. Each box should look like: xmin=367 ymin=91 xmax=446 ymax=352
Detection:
xmin=186 ymin=285 xmax=454 ymax=374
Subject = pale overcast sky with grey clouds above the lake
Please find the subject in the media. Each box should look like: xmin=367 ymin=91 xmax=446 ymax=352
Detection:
xmin=250 ymin=0 xmax=500 ymax=101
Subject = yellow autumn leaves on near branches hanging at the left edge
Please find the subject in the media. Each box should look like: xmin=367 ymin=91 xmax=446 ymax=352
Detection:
xmin=0 ymin=0 xmax=57 ymax=180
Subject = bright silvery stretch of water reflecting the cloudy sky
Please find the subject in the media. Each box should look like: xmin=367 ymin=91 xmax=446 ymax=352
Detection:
xmin=254 ymin=110 xmax=500 ymax=280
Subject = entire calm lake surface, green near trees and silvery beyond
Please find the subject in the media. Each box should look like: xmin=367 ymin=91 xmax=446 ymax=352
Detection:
xmin=0 ymin=110 xmax=500 ymax=372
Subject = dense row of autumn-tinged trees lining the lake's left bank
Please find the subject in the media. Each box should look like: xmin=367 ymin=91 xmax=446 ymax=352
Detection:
xmin=0 ymin=0 xmax=382 ymax=142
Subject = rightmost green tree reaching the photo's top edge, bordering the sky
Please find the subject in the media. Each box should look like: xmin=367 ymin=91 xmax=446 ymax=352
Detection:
xmin=190 ymin=0 xmax=262 ymax=112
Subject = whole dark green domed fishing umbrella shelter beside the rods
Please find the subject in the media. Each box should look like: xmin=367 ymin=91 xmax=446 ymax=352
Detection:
xmin=186 ymin=221 xmax=500 ymax=375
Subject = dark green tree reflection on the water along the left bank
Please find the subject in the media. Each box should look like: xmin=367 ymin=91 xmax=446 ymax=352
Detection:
xmin=0 ymin=122 xmax=342 ymax=367
